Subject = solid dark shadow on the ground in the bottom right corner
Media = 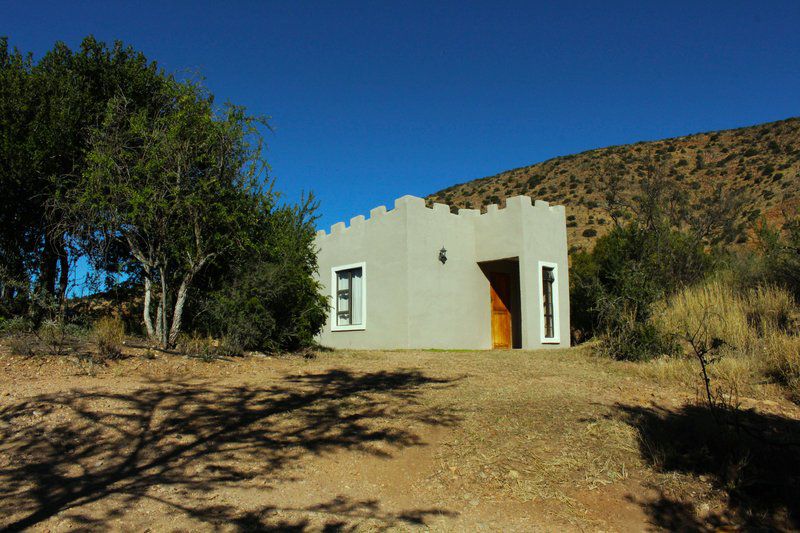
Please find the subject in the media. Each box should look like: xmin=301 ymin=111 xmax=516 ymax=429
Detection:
xmin=617 ymin=404 xmax=800 ymax=531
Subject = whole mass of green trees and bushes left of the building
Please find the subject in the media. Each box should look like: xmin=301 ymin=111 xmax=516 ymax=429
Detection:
xmin=0 ymin=37 xmax=322 ymax=353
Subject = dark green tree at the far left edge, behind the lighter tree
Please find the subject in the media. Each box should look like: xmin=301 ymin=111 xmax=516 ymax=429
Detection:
xmin=0 ymin=37 xmax=166 ymax=312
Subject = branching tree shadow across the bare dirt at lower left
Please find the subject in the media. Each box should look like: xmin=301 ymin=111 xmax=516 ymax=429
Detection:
xmin=0 ymin=370 xmax=459 ymax=531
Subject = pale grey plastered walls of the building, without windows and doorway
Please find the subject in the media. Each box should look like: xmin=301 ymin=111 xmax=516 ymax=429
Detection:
xmin=315 ymin=196 xmax=569 ymax=349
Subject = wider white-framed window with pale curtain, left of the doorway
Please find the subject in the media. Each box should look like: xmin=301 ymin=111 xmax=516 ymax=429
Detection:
xmin=331 ymin=263 xmax=367 ymax=331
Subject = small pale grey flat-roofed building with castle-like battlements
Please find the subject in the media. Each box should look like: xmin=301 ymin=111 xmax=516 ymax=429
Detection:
xmin=315 ymin=196 xmax=570 ymax=349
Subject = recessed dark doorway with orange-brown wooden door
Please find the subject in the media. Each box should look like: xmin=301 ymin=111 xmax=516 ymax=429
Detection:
xmin=479 ymin=258 xmax=522 ymax=350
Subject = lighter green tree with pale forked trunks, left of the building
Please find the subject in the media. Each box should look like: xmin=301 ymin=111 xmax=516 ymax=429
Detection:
xmin=59 ymin=80 xmax=274 ymax=347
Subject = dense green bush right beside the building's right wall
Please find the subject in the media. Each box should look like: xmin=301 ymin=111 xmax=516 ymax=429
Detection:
xmin=570 ymin=224 xmax=713 ymax=360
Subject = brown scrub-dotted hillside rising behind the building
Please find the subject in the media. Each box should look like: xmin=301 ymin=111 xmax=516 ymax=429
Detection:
xmin=426 ymin=118 xmax=800 ymax=247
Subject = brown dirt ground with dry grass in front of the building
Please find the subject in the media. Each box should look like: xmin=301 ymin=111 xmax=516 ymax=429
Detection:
xmin=0 ymin=342 xmax=800 ymax=532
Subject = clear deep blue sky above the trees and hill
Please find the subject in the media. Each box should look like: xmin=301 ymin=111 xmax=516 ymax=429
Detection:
xmin=6 ymin=0 xmax=800 ymax=231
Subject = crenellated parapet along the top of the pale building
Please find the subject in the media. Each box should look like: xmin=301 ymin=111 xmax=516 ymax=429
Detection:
xmin=317 ymin=195 xmax=564 ymax=240
